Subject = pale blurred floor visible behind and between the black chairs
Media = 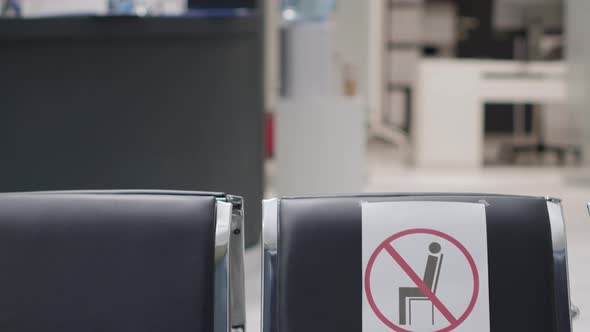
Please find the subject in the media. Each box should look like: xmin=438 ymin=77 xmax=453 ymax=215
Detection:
xmin=246 ymin=143 xmax=590 ymax=332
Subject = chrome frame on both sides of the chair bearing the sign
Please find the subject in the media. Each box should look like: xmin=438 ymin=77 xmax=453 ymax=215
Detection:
xmin=261 ymin=194 xmax=590 ymax=332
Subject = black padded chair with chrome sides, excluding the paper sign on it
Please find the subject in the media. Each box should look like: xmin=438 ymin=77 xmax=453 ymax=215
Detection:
xmin=262 ymin=193 xmax=574 ymax=332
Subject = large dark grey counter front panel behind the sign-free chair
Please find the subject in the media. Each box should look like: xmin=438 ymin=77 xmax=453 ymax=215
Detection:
xmin=0 ymin=16 xmax=263 ymax=244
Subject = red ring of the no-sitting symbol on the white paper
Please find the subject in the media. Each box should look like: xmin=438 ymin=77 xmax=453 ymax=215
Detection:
xmin=365 ymin=228 xmax=479 ymax=332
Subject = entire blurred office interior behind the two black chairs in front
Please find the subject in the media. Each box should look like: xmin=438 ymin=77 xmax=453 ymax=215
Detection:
xmin=0 ymin=0 xmax=590 ymax=331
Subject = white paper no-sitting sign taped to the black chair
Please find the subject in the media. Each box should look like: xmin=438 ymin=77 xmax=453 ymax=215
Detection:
xmin=362 ymin=202 xmax=490 ymax=332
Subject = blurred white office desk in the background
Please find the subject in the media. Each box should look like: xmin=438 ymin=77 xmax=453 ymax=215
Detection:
xmin=412 ymin=59 xmax=566 ymax=168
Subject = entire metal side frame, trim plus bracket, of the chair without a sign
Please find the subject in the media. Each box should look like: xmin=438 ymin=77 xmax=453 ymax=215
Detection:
xmin=213 ymin=195 xmax=246 ymax=332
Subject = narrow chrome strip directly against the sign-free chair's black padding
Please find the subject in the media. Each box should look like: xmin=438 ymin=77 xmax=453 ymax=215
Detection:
xmin=213 ymin=200 xmax=232 ymax=332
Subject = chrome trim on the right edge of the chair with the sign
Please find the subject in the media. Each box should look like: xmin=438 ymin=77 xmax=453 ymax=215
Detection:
xmin=546 ymin=197 xmax=572 ymax=332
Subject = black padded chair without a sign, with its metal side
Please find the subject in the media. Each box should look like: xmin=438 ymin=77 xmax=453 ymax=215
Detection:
xmin=0 ymin=191 xmax=245 ymax=332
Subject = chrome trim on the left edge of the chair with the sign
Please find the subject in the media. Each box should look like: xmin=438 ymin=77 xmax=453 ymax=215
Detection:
xmin=260 ymin=198 xmax=279 ymax=332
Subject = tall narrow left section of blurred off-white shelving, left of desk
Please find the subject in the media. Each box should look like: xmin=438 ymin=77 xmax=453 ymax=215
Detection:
xmin=369 ymin=0 xmax=424 ymax=147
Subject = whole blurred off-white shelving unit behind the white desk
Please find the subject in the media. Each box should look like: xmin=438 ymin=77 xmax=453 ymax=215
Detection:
xmin=368 ymin=0 xmax=457 ymax=149
